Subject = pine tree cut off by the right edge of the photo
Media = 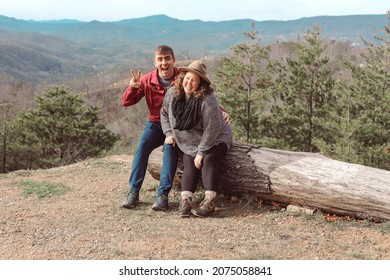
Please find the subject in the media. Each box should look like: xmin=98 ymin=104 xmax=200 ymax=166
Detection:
xmin=340 ymin=11 xmax=390 ymax=170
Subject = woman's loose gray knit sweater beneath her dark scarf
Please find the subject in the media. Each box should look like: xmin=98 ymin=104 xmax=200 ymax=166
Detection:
xmin=161 ymin=87 xmax=233 ymax=157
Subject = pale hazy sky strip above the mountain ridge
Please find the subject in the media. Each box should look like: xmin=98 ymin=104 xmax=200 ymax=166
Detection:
xmin=0 ymin=0 xmax=390 ymax=21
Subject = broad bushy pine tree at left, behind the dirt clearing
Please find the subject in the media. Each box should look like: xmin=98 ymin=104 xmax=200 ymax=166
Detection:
xmin=7 ymin=86 xmax=118 ymax=169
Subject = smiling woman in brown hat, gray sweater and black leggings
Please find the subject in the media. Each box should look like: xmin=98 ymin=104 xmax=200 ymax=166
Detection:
xmin=161 ymin=61 xmax=233 ymax=217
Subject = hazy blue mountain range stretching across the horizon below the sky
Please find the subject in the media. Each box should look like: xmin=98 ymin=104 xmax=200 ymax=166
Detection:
xmin=0 ymin=14 xmax=387 ymax=82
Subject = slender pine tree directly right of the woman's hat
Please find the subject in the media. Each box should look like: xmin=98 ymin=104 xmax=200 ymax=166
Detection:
xmin=214 ymin=24 xmax=271 ymax=142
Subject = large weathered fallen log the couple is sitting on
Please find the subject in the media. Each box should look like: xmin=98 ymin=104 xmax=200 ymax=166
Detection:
xmin=148 ymin=143 xmax=390 ymax=221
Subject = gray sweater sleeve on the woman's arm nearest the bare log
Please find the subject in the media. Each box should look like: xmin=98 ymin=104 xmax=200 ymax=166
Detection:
xmin=198 ymin=94 xmax=223 ymax=156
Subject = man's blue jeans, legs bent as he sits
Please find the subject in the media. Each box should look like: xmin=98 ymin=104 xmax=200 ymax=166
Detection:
xmin=129 ymin=121 xmax=178 ymax=196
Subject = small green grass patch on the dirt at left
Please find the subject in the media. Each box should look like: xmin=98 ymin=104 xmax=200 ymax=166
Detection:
xmin=20 ymin=180 xmax=70 ymax=198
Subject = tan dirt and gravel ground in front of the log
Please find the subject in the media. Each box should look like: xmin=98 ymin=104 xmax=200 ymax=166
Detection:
xmin=0 ymin=155 xmax=390 ymax=260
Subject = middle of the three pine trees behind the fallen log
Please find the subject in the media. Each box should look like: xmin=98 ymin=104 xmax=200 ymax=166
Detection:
xmin=262 ymin=26 xmax=335 ymax=152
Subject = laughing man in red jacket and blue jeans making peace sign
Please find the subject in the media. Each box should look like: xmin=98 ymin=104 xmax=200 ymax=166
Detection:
xmin=122 ymin=45 xmax=229 ymax=211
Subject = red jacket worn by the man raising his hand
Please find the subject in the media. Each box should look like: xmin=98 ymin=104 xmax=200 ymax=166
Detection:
xmin=122 ymin=68 xmax=179 ymax=122
